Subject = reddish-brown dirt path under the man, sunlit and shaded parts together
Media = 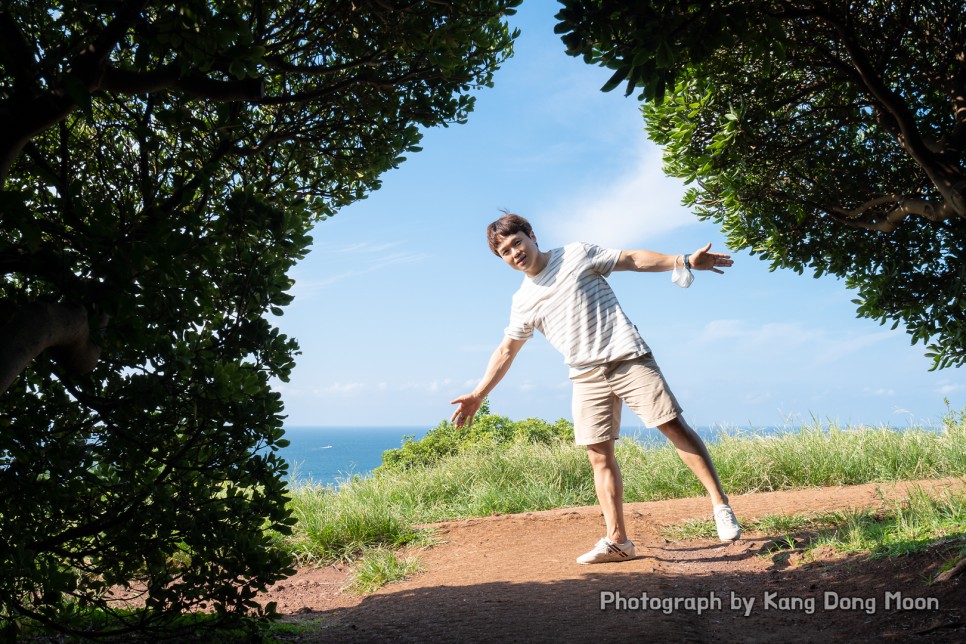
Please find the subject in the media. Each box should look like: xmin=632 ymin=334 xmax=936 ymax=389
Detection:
xmin=261 ymin=479 xmax=966 ymax=642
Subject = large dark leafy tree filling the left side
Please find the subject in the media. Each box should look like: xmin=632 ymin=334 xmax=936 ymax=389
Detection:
xmin=0 ymin=0 xmax=519 ymax=635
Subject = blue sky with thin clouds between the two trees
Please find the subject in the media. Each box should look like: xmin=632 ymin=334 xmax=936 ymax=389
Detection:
xmin=275 ymin=0 xmax=966 ymax=427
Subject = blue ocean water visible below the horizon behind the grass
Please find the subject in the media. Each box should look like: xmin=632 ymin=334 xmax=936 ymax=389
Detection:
xmin=279 ymin=427 xmax=777 ymax=485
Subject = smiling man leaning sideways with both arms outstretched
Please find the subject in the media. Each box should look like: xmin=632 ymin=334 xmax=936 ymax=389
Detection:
xmin=450 ymin=214 xmax=741 ymax=564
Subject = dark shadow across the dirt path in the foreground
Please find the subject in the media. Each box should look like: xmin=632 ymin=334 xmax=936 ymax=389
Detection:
xmin=290 ymin=539 xmax=966 ymax=643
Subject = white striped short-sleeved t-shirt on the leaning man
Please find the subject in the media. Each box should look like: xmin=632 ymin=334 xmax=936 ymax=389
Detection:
xmin=505 ymin=242 xmax=650 ymax=377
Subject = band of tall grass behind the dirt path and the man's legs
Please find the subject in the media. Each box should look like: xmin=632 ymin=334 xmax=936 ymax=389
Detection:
xmin=283 ymin=415 xmax=966 ymax=561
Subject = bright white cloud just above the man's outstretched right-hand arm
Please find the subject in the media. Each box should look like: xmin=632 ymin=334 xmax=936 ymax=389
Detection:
xmin=545 ymin=144 xmax=699 ymax=248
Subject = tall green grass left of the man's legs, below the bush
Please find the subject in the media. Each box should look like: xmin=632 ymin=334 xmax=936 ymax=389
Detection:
xmin=277 ymin=441 xmax=595 ymax=563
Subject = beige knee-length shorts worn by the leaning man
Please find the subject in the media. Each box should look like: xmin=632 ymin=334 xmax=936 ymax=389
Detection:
xmin=572 ymin=353 xmax=681 ymax=445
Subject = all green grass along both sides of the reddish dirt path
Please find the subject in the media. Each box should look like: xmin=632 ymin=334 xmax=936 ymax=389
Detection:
xmin=21 ymin=418 xmax=966 ymax=642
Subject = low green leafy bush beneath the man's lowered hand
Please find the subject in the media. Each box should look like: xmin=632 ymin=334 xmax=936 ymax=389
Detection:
xmin=376 ymin=401 xmax=574 ymax=473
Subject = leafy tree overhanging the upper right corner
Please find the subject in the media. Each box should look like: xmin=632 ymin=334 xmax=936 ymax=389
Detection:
xmin=557 ymin=0 xmax=966 ymax=368
